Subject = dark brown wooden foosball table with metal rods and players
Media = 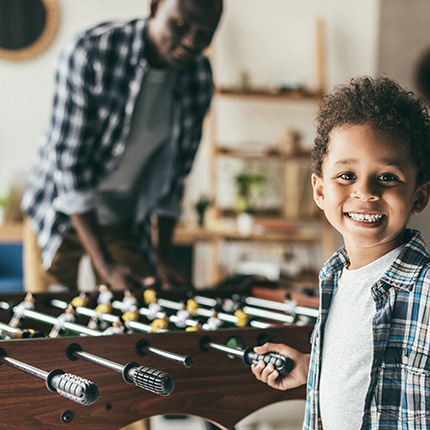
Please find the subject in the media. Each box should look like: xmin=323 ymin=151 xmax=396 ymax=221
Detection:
xmin=0 ymin=287 xmax=317 ymax=430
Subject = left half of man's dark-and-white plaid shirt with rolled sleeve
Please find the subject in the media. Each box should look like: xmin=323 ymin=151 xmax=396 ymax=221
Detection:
xmin=21 ymin=20 xmax=145 ymax=268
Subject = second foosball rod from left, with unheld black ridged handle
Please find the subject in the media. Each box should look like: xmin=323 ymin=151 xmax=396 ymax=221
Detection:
xmin=67 ymin=343 xmax=175 ymax=396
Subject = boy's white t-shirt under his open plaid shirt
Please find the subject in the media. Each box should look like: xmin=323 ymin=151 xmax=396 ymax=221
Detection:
xmin=320 ymin=247 xmax=402 ymax=430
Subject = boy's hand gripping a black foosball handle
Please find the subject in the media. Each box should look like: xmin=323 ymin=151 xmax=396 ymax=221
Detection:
xmin=251 ymin=343 xmax=310 ymax=390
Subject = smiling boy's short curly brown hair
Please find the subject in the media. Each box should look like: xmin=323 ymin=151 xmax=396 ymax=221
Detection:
xmin=312 ymin=76 xmax=430 ymax=185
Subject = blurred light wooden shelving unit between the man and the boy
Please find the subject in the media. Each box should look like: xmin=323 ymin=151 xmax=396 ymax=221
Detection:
xmin=175 ymin=21 xmax=335 ymax=288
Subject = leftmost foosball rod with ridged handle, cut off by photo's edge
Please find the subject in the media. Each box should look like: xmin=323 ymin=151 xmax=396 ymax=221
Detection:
xmin=0 ymin=348 xmax=99 ymax=406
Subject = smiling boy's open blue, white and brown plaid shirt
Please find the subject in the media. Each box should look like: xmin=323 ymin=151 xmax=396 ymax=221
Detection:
xmin=303 ymin=230 xmax=430 ymax=430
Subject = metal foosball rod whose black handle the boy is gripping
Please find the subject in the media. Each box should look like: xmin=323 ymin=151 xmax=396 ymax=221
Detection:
xmin=200 ymin=336 xmax=294 ymax=378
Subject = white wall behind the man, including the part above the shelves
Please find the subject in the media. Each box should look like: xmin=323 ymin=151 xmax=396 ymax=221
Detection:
xmin=0 ymin=0 xmax=378 ymax=202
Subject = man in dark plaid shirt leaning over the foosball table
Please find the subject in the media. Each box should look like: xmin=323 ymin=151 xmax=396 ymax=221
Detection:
xmin=22 ymin=0 xmax=222 ymax=292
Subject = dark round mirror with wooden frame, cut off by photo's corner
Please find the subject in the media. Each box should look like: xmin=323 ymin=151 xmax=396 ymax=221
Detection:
xmin=0 ymin=0 xmax=58 ymax=60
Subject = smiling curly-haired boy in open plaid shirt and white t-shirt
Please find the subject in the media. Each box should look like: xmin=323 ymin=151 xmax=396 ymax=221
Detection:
xmin=252 ymin=77 xmax=430 ymax=430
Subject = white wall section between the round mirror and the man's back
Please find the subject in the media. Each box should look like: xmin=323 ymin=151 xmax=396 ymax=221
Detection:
xmin=0 ymin=0 xmax=149 ymax=196
